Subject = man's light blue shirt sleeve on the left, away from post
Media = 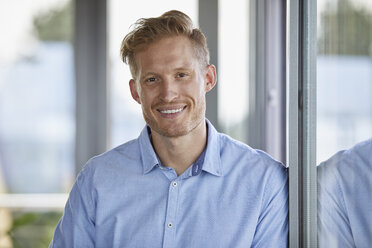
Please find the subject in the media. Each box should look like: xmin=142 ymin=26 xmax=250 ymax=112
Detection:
xmin=49 ymin=167 xmax=95 ymax=248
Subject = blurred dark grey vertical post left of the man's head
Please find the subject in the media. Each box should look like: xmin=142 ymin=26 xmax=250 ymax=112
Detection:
xmin=75 ymin=0 xmax=109 ymax=173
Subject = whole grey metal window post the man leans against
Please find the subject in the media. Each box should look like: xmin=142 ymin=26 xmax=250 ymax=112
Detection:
xmin=287 ymin=0 xmax=317 ymax=247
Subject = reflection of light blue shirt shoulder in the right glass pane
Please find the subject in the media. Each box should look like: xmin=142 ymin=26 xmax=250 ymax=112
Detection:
xmin=318 ymin=139 xmax=372 ymax=248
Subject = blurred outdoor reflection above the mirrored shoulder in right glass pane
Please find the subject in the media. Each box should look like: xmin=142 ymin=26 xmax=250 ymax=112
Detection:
xmin=317 ymin=0 xmax=372 ymax=164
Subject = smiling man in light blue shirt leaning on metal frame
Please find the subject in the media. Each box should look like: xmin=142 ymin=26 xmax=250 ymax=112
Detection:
xmin=51 ymin=11 xmax=288 ymax=248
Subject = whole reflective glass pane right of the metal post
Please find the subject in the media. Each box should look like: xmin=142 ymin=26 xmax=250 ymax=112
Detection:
xmin=317 ymin=0 xmax=372 ymax=247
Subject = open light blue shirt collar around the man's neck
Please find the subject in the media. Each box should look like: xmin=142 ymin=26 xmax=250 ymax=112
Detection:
xmin=139 ymin=119 xmax=222 ymax=176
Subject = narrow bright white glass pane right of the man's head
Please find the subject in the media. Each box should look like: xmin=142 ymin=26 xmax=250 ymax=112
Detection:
xmin=217 ymin=0 xmax=249 ymax=142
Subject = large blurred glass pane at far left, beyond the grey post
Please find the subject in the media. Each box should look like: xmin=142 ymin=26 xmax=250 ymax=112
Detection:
xmin=0 ymin=0 xmax=75 ymax=193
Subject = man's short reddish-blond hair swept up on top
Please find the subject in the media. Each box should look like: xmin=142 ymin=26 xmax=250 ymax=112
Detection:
xmin=120 ymin=10 xmax=209 ymax=79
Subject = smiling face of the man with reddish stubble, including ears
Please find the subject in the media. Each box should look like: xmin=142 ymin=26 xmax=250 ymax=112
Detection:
xmin=129 ymin=36 xmax=216 ymax=137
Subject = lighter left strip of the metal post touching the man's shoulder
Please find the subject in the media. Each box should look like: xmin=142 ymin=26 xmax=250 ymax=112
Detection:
xmin=286 ymin=1 xmax=302 ymax=248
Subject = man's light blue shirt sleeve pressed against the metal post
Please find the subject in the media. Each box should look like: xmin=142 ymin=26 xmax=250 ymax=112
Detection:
xmin=252 ymin=164 xmax=288 ymax=248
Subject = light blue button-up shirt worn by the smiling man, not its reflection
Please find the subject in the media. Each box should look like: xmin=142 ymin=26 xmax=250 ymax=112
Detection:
xmin=50 ymin=121 xmax=288 ymax=248
